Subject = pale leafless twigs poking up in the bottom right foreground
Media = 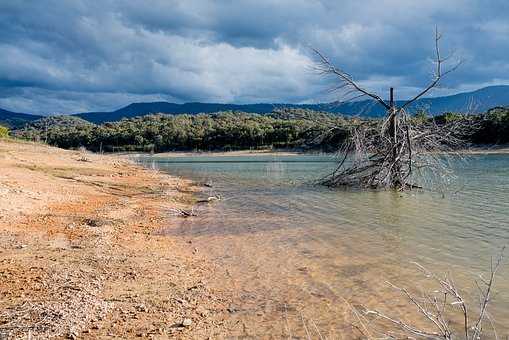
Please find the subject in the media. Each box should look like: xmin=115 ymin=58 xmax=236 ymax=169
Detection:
xmin=352 ymin=251 xmax=505 ymax=340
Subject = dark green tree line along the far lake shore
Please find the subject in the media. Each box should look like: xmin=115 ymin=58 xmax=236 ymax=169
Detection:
xmin=14 ymin=108 xmax=509 ymax=152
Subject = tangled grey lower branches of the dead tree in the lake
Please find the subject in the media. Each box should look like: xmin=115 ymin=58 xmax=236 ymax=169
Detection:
xmin=321 ymin=111 xmax=477 ymax=190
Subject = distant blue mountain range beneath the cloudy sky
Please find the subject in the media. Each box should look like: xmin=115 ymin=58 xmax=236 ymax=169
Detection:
xmin=0 ymin=85 xmax=509 ymax=127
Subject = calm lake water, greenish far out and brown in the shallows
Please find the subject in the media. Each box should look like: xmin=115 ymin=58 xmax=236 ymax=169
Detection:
xmin=135 ymin=155 xmax=509 ymax=338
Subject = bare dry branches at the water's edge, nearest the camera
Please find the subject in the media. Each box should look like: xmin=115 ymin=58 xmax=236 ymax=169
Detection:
xmin=354 ymin=247 xmax=505 ymax=340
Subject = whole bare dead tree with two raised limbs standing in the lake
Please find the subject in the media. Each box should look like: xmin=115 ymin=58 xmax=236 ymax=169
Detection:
xmin=314 ymin=30 xmax=472 ymax=190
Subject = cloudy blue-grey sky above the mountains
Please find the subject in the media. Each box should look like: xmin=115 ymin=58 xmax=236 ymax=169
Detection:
xmin=0 ymin=0 xmax=509 ymax=113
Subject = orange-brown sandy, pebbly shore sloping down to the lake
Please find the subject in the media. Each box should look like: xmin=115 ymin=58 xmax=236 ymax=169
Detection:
xmin=0 ymin=141 xmax=227 ymax=339
